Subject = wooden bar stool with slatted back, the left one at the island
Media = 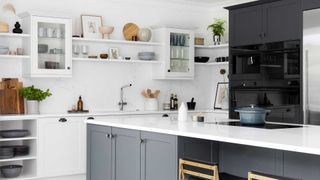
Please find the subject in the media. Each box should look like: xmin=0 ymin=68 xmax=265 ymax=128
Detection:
xmin=179 ymin=159 xmax=219 ymax=180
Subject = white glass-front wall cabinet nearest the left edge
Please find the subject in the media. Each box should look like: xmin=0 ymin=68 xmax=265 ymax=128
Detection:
xmin=20 ymin=12 xmax=72 ymax=77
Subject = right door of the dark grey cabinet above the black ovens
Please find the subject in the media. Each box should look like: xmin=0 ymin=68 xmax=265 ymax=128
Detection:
xmin=263 ymin=0 xmax=302 ymax=42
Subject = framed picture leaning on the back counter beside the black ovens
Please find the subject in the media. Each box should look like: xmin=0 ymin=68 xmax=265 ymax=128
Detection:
xmin=214 ymin=82 xmax=229 ymax=109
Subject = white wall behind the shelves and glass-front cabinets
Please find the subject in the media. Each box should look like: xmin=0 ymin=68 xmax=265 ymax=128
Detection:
xmin=0 ymin=0 xmax=227 ymax=113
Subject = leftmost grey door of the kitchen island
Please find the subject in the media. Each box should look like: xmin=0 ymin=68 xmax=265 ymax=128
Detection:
xmin=87 ymin=125 xmax=112 ymax=180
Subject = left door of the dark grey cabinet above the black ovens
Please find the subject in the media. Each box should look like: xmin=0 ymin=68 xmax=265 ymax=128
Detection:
xmin=229 ymin=5 xmax=263 ymax=46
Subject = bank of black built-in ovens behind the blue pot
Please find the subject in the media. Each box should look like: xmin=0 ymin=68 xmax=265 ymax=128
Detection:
xmin=230 ymin=41 xmax=302 ymax=123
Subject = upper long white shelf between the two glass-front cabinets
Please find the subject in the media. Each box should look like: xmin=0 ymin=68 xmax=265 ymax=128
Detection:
xmin=72 ymin=38 xmax=162 ymax=46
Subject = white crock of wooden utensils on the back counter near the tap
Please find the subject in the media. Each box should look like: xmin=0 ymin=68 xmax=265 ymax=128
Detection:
xmin=141 ymin=89 xmax=160 ymax=111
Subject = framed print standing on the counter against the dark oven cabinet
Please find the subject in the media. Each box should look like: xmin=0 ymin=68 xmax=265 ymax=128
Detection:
xmin=214 ymin=82 xmax=229 ymax=110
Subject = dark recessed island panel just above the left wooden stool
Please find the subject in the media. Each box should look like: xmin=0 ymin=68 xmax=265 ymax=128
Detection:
xmin=178 ymin=137 xmax=219 ymax=163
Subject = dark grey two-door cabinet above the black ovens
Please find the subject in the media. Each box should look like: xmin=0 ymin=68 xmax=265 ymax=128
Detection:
xmin=229 ymin=0 xmax=302 ymax=47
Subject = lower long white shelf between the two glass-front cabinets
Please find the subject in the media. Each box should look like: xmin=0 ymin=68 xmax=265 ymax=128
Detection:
xmin=73 ymin=58 xmax=161 ymax=64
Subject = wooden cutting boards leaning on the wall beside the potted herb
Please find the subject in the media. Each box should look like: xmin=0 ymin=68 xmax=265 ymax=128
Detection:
xmin=0 ymin=78 xmax=24 ymax=114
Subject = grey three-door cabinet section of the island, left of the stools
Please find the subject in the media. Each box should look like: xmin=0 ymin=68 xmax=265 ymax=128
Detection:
xmin=87 ymin=125 xmax=178 ymax=180
